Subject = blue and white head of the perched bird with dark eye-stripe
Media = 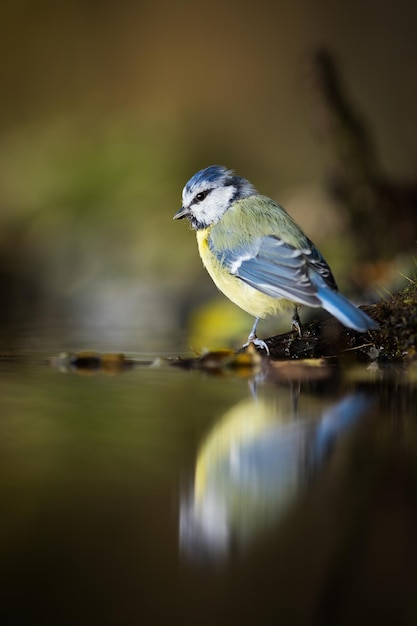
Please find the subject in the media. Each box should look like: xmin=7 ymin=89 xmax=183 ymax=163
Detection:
xmin=174 ymin=165 xmax=257 ymax=230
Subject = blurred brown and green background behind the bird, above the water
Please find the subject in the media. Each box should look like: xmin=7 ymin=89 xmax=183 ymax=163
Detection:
xmin=0 ymin=0 xmax=417 ymax=352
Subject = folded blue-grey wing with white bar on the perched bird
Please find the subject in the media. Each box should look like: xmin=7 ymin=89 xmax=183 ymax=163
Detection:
xmin=212 ymin=236 xmax=337 ymax=306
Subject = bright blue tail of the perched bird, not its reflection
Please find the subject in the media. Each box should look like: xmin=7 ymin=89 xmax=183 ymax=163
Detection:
xmin=317 ymin=285 xmax=379 ymax=333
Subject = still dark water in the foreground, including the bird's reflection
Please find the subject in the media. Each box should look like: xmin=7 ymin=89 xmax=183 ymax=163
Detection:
xmin=0 ymin=342 xmax=417 ymax=626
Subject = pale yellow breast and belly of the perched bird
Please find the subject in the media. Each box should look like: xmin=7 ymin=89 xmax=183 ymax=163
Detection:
xmin=197 ymin=227 xmax=294 ymax=318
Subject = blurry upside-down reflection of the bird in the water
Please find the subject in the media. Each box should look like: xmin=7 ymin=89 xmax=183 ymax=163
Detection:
xmin=179 ymin=394 xmax=369 ymax=557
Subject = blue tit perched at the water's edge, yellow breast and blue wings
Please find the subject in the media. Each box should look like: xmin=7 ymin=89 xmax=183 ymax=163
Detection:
xmin=174 ymin=165 xmax=378 ymax=352
